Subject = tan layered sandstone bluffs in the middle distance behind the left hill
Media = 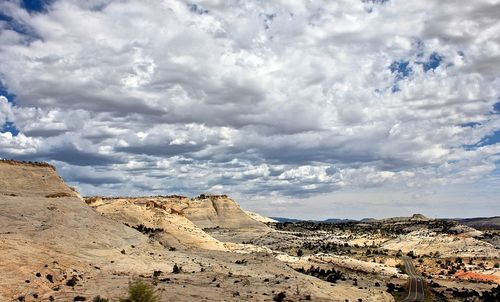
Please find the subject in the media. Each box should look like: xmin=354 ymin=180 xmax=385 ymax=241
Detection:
xmin=86 ymin=195 xmax=271 ymax=251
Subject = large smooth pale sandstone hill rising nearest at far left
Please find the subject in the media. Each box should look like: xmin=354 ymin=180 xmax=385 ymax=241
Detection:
xmin=0 ymin=161 xmax=169 ymax=301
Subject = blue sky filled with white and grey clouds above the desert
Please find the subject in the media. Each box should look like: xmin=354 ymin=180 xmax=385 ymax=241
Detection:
xmin=0 ymin=0 xmax=500 ymax=219
